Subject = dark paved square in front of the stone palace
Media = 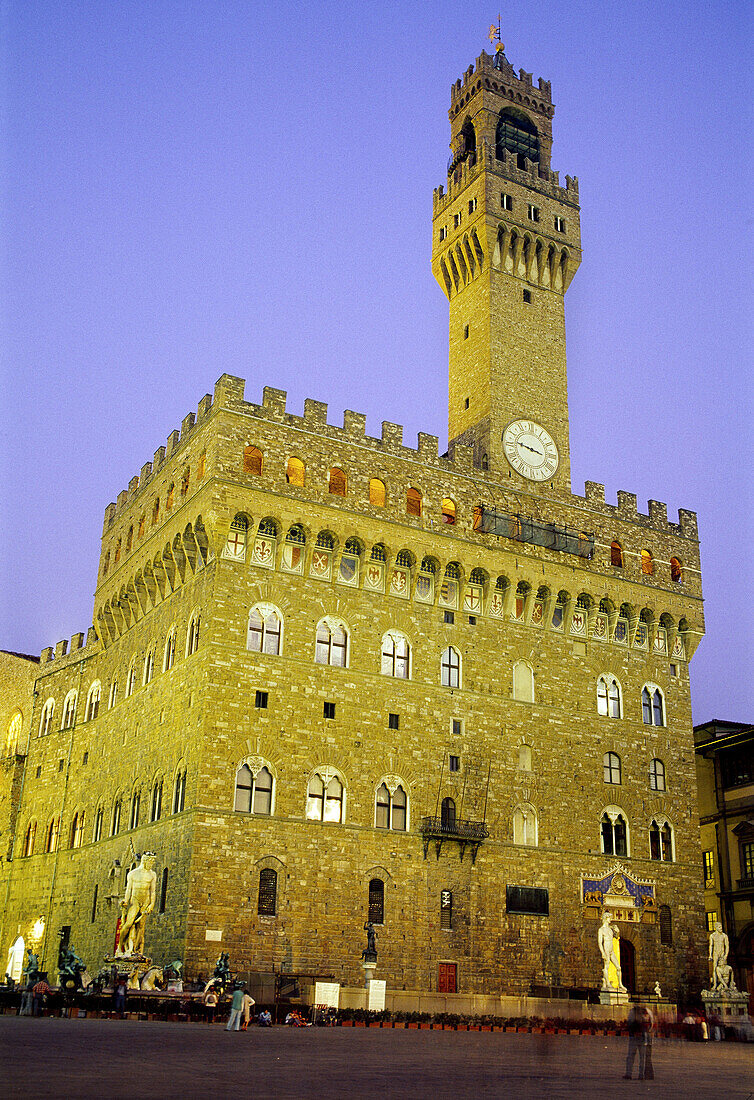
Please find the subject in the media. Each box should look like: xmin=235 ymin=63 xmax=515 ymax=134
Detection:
xmin=0 ymin=1016 xmax=754 ymax=1100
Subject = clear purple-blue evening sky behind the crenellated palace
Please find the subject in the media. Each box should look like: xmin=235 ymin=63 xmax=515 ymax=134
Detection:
xmin=0 ymin=0 xmax=754 ymax=722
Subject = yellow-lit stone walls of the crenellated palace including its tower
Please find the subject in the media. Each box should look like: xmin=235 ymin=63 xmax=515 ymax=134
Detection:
xmin=0 ymin=47 xmax=704 ymax=994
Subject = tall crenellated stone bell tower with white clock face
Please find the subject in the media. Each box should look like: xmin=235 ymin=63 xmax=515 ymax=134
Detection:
xmin=433 ymin=48 xmax=581 ymax=491
